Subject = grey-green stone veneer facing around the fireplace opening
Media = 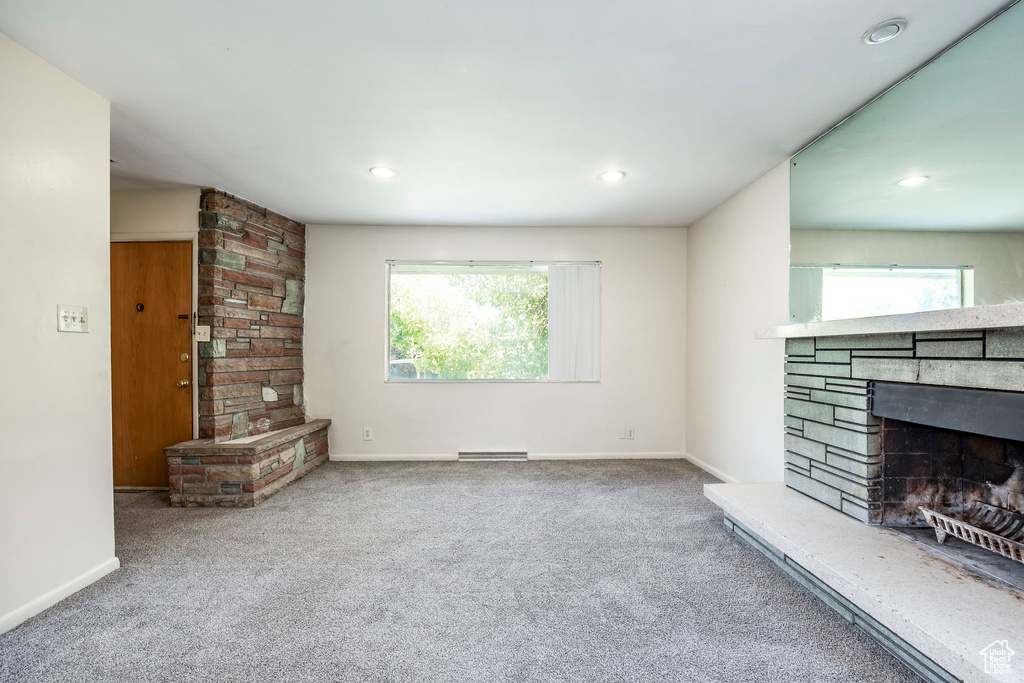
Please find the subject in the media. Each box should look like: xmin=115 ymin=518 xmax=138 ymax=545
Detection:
xmin=784 ymin=328 xmax=1024 ymax=524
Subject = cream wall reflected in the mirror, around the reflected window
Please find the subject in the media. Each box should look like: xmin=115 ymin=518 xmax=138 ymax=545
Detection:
xmin=791 ymin=230 xmax=1024 ymax=306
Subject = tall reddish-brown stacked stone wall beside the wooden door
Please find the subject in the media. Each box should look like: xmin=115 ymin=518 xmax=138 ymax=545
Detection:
xmin=198 ymin=189 xmax=306 ymax=441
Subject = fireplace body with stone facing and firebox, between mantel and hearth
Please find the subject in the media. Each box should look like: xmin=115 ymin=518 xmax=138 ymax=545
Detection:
xmin=785 ymin=328 xmax=1024 ymax=573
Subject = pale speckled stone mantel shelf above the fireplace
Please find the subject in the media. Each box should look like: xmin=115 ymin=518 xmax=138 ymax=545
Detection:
xmin=754 ymin=303 xmax=1024 ymax=339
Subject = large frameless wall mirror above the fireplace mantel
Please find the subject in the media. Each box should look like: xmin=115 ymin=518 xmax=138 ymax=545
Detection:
xmin=790 ymin=3 xmax=1024 ymax=323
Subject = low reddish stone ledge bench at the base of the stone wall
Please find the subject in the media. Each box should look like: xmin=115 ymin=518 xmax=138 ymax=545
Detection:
xmin=164 ymin=420 xmax=331 ymax=508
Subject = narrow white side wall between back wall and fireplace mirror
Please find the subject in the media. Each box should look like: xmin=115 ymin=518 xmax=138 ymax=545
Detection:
xmin=686 ymin=162 xmax=790 ymax=481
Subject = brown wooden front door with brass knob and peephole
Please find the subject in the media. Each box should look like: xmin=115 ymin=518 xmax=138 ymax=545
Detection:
xmin=111 ymin=242 xmax=193 ymax=487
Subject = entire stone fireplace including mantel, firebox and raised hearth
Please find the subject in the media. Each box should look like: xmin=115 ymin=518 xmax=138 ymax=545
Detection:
xmin=705 ymin=315 xmax=1024 ymax=681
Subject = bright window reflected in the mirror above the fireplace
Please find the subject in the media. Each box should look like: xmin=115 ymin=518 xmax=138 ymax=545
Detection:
xmin=790 ymin=265 xmax=974 ymax=321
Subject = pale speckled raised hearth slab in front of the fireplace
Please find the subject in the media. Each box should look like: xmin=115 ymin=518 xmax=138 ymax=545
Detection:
xmin=705 ymin=482 xmax=1024 ymax=682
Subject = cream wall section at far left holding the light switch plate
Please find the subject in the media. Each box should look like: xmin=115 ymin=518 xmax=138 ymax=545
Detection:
xmin=0 ymin=30 xmax=118 ymax=632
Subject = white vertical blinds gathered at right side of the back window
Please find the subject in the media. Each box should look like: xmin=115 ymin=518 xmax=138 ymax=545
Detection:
xmin=548 ymin=264 xmax=601 ymax=382
